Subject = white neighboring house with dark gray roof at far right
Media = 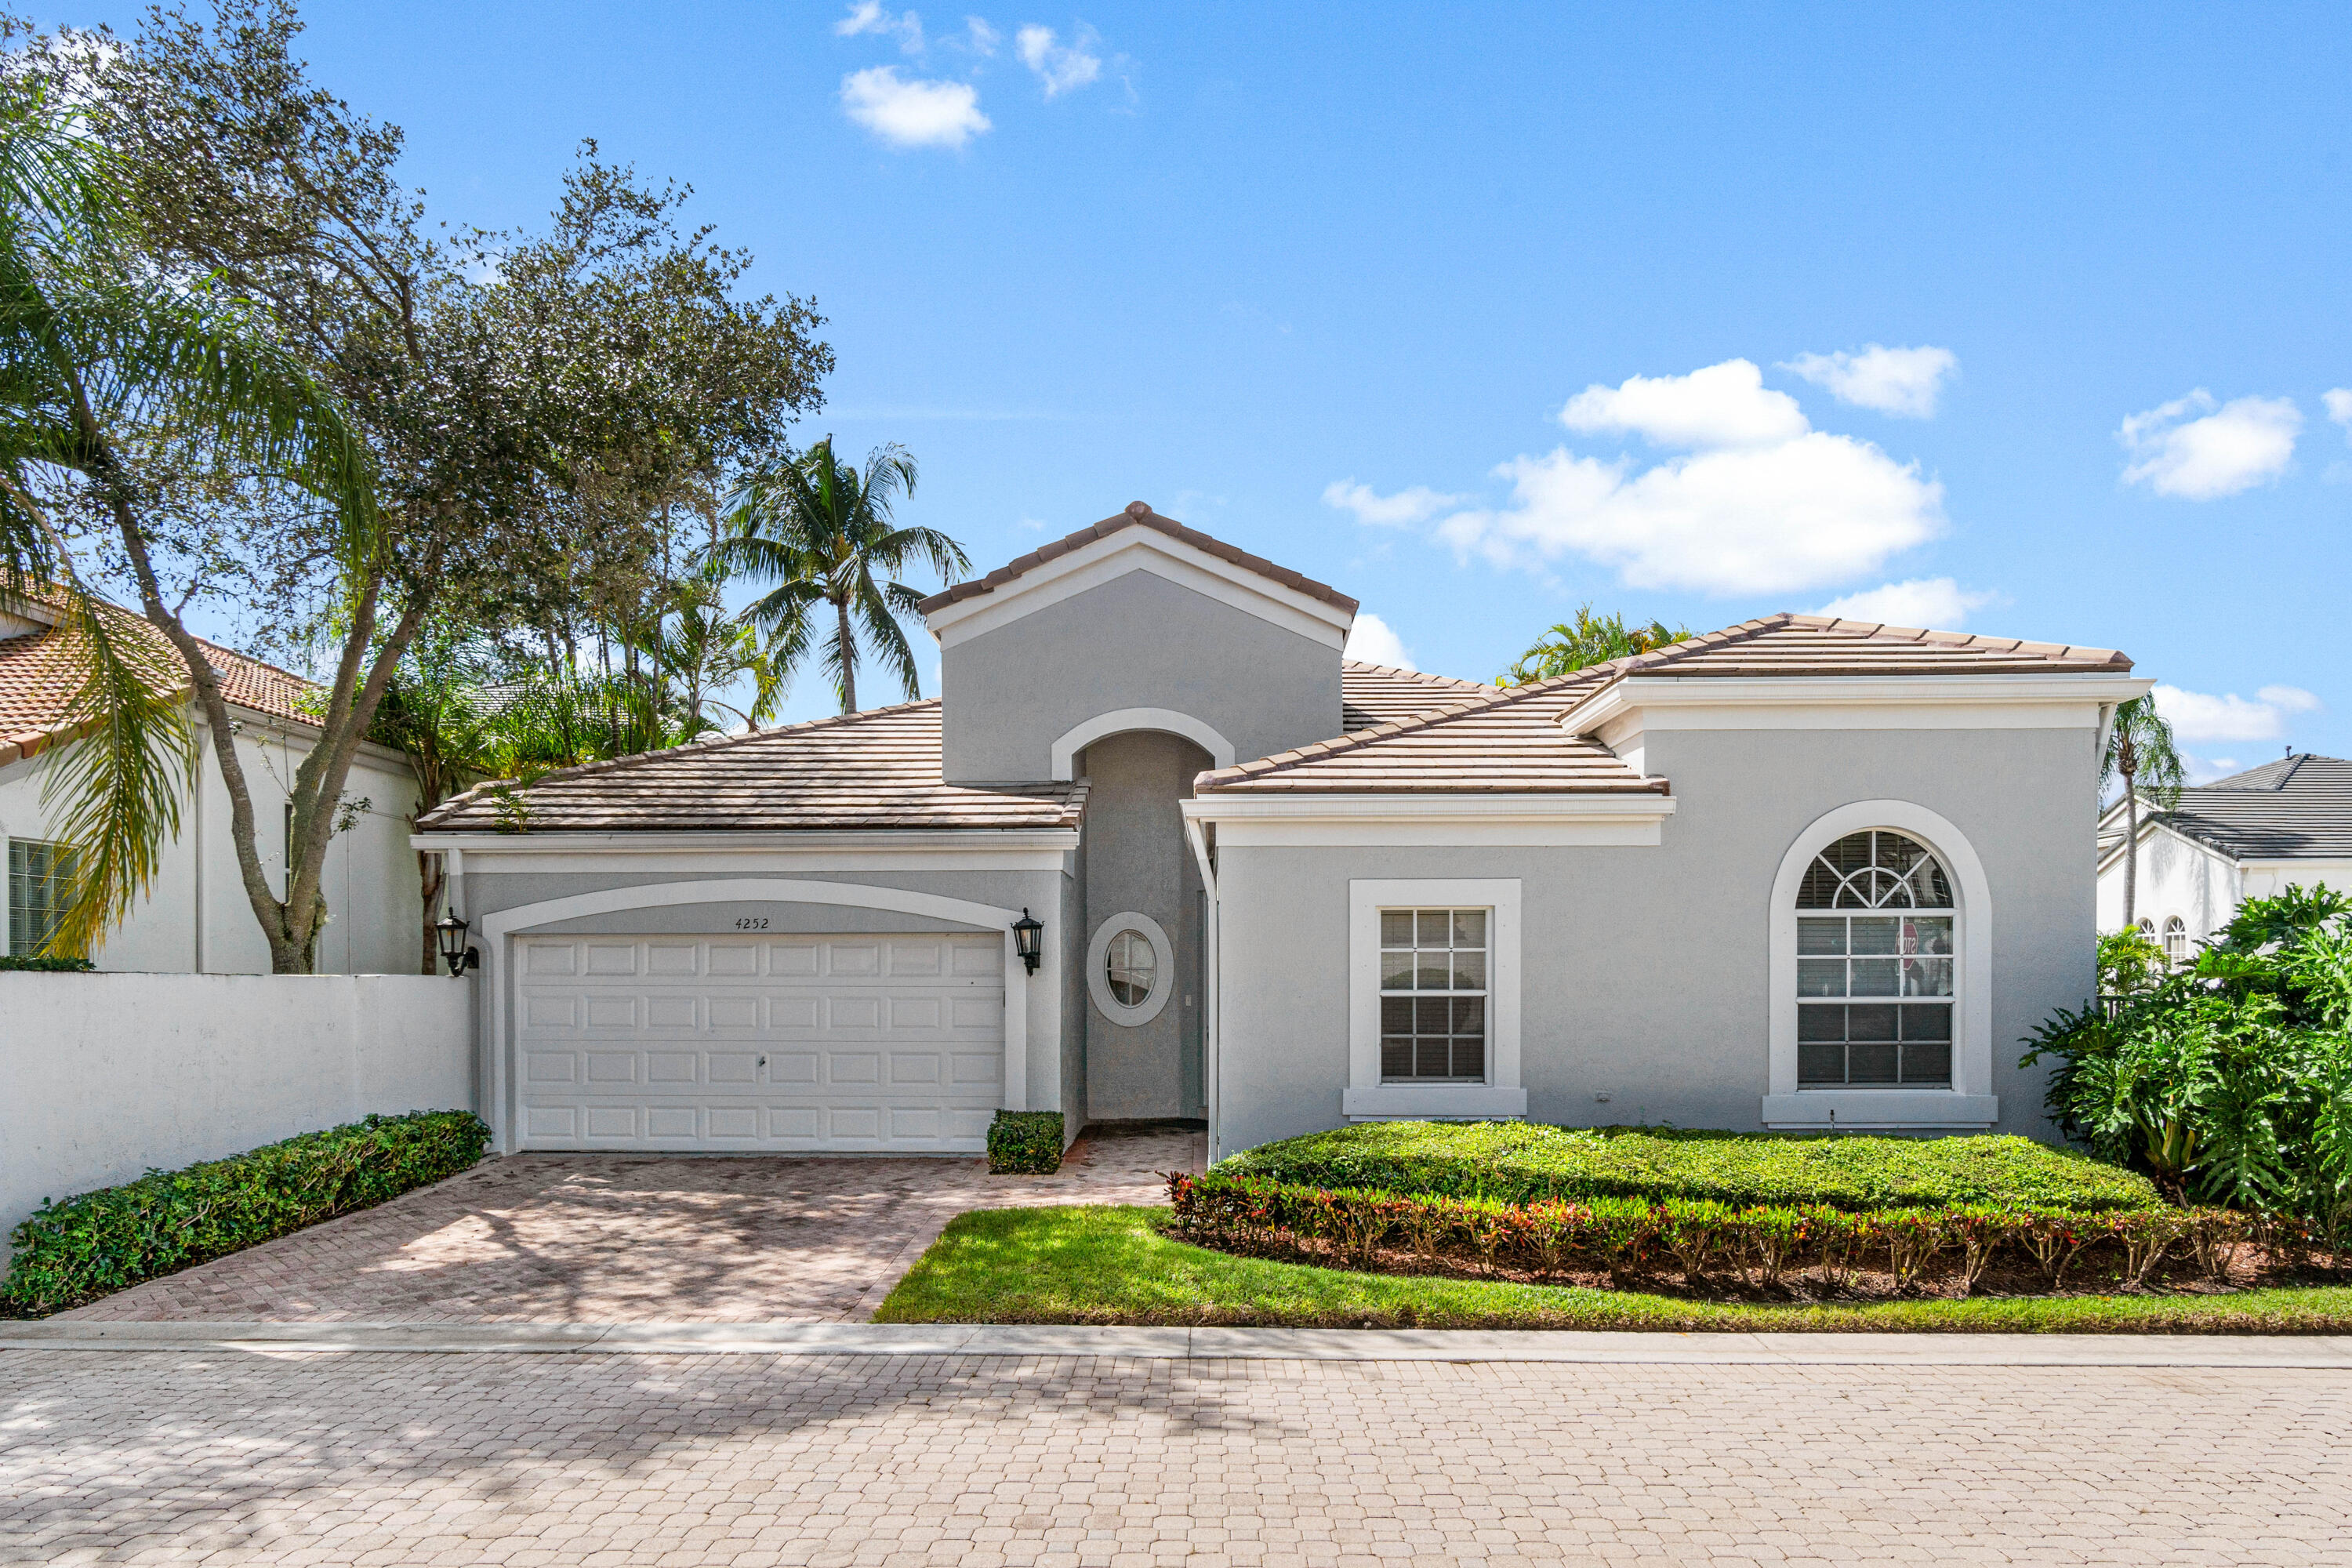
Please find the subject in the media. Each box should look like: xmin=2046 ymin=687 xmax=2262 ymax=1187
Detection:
xmin=2098 ymin=753 xmax=2352 ymax=964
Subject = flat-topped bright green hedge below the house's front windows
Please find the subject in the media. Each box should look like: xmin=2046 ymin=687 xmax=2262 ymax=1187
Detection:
xmin=1216 ymin=1121 xmax=2164 ymax=1213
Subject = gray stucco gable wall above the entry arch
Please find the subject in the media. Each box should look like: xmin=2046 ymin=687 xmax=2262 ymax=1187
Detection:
xmin=941 ymin=572 xmax=1341 ymax=783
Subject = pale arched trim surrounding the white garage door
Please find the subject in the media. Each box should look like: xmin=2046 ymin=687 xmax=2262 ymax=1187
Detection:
xmin=480 ymin=877 xmax=1056 ymax=1152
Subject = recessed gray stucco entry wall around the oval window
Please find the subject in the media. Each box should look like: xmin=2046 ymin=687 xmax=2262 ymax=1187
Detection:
xmin=1084 ymin=734 xmax=1209 ymax=1121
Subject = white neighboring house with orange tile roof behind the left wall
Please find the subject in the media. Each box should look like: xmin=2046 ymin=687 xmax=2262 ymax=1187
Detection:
xmin=0 ymin=600 xmax=423 ymax=973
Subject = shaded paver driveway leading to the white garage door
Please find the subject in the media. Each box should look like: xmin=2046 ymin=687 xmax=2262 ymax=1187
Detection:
xmin=61 ymin=1128 xmax=1204 ymax=1323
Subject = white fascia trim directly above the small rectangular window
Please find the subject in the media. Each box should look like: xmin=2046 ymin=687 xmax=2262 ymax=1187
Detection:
xmin=1178 ymin=792 xmax=1675 ymax=848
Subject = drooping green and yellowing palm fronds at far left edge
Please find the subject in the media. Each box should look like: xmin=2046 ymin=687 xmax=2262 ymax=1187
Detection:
xmin=0 ymin=92 xmax=374 ymax=954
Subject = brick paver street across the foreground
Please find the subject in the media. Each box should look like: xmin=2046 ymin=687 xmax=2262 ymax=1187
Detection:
xmin=0 ymin=1349 xmax=2352 ymax=1568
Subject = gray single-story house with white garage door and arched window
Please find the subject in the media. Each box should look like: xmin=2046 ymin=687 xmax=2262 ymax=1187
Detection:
xmin=414 ymin=501 xmax=2150 ymax=1154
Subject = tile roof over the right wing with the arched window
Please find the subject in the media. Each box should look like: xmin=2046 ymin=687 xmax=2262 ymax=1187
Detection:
xmin=1195 ymin=614 xmax=2131 ymax=794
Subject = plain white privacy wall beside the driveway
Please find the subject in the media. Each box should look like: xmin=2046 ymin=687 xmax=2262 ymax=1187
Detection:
xmin=0 ymin=973 xmax=473 ymax=1250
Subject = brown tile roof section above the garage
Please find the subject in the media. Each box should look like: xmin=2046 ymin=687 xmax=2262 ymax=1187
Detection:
xmin=416 ymin=699 xmax=1087 ymax=832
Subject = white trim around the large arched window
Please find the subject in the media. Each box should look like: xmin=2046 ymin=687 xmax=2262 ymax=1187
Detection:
xmin=1764 ymin=799 xmax=2002 ymax=1128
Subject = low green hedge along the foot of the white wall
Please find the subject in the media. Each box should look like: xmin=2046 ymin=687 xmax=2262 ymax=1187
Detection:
xmin=0 ymin=1109 xmax=489 ymax=1316
